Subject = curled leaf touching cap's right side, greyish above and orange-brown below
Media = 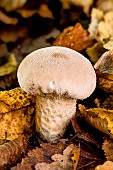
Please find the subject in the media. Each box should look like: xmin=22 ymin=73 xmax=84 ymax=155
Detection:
xmin=94 ymin=50 xmax=113 ymax=92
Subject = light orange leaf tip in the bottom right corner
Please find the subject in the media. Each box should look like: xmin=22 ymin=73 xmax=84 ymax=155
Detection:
xmin=95 ymin=161 xmax=113 ymax=170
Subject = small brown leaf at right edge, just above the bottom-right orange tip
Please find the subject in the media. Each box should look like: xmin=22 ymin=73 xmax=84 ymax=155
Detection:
xmin=102 ymin=137 xmax=113 ymax=161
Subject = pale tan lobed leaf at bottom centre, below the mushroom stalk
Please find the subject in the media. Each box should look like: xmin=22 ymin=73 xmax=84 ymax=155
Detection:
xmin=35 ymin=144 xmax=80 ymax=170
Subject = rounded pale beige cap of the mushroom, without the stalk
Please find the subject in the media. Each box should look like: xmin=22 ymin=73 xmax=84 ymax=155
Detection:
xmin=17 ymin=46 xmax=96 ymax=99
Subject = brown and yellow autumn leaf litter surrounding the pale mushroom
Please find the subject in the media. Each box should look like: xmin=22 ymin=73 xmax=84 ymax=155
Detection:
xmin=0 ymin=0 xmax=113 ymax=170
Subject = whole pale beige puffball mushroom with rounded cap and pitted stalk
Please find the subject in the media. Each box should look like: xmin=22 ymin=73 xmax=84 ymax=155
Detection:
xmin=17 ymin=46 xmax=96 ymax=143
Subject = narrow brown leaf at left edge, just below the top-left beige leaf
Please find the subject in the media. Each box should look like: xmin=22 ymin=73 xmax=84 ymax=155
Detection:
xmin=0 ymin=11 xmax=19 ymax=25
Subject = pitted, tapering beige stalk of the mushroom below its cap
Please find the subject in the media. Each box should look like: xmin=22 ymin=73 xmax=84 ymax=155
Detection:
xmin=36 ymin=96 xmax=76 ymax=143
